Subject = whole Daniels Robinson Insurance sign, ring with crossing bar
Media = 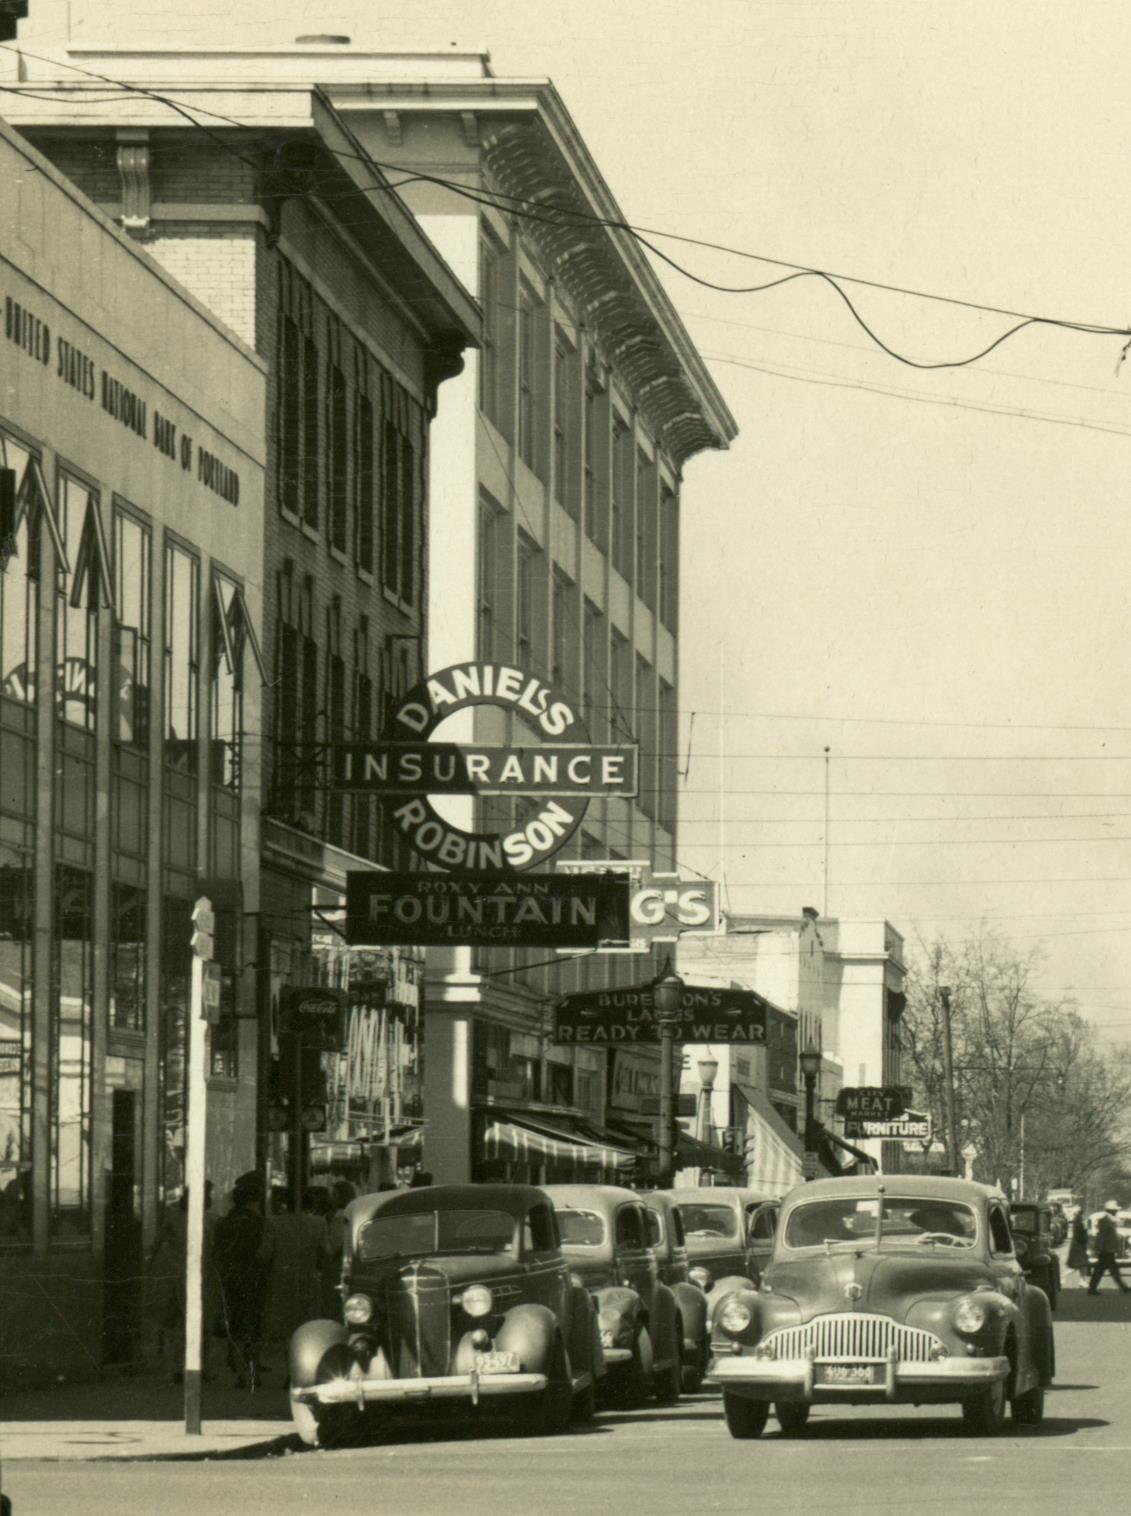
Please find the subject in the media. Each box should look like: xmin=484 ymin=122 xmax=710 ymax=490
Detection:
xmin=329 ymin=662 xmax=638 ymax=873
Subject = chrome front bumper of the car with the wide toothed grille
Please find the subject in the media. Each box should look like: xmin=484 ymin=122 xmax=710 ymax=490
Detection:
xmin=706 ymin=1354 xmax=1010 ymax=1401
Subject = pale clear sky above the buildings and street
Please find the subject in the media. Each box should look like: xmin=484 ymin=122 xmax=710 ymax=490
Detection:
xmin=23 ymin=0 xmax=1131 ymax=1045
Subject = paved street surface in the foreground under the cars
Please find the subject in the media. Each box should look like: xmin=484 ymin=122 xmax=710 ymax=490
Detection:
xmin=5 ymin=1284 xmax=1131 ymax=1516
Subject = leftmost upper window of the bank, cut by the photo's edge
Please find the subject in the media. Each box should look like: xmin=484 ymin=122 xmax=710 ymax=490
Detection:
xmin=0 ymin=434 xmax=41 ymax=703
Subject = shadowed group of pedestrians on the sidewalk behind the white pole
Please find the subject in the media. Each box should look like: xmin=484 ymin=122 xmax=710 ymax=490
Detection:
xmin=150 ymin=1172 xmax=355 ymax=1389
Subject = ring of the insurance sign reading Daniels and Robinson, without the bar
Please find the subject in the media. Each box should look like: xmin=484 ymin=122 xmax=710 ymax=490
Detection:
xmin=384 ymin=662 xmax=590 ymax=873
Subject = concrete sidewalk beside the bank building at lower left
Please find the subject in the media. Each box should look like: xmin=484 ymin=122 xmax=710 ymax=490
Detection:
xmin=0 ymin=1373 xmax=293 ymax=1463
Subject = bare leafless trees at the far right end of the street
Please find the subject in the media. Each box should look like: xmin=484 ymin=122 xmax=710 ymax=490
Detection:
xmin=904 ymin=931 xmax=1131 ymax=1195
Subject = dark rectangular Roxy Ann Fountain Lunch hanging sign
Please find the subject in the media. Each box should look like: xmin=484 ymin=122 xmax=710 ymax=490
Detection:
xmin=346 ymin=869 xmax=628 ymax=948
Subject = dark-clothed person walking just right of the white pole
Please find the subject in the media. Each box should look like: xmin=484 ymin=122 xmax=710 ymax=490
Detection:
xmin=215 ymin=1170 xmax=271 ymax=1389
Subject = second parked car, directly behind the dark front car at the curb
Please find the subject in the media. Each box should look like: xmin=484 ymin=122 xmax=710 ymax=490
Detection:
xmin=546 ymin=1184 xmax=684 ymax=1405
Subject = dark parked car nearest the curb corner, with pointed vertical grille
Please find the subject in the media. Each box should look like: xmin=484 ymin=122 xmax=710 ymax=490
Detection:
xmin=290 ymin=1184 xmax=603 ymax=1445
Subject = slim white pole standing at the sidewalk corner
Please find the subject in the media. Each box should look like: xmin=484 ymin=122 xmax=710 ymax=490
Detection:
xmin=183 ymin=894 xmax=220 ymax=1436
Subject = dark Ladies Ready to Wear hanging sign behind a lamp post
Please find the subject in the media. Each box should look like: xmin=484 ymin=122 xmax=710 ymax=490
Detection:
xmin=553 ymin=984 xmax=770 ymax=1045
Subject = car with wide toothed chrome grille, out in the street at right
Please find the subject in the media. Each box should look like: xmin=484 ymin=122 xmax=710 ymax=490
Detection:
xmin=706 ymin=1175 xmax=1055 ymax=1437
